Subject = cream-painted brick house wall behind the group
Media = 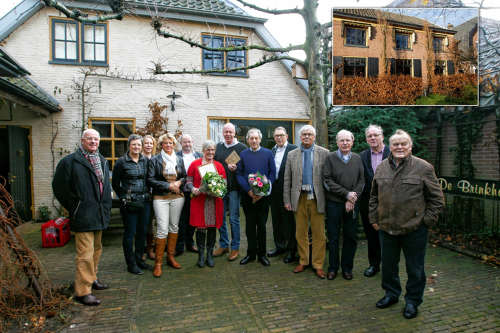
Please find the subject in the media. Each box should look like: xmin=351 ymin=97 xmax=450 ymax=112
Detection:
xmin=0 ymin=8 xmax=309 ymax=217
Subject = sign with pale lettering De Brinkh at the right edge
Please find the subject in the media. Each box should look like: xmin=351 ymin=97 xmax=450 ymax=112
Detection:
xmin=438 ymin=177 xmax=500 ymax=200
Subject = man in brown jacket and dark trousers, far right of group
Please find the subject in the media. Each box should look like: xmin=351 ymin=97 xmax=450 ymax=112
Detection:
xmin=370 ymin=130 xmax=444 ymax=319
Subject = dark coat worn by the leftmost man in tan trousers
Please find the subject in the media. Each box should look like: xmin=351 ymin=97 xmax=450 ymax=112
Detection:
xmin=52 ymin=150 xmax=111 ymax=232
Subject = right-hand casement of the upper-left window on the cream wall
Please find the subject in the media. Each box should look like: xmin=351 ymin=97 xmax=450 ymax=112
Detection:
xmin=82 ymin=23 xmax=108 ymax=64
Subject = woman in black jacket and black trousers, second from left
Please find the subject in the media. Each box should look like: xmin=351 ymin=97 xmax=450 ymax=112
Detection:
xmin=112 ymin=134 xmax=152 ymax=275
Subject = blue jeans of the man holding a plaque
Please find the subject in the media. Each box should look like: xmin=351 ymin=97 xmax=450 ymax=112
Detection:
xmin=219 ymin=191 xmax=240 ymax=250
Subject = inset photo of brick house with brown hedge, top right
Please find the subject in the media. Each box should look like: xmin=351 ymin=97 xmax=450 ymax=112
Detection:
xmin=332 ymin=8 xmax=479 ymax=106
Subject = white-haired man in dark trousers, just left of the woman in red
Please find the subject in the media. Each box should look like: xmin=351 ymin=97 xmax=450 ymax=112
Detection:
xmin=175 ymin=134 xmax=203 ymax=256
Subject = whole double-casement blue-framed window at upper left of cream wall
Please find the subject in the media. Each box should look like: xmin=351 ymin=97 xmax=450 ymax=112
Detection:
xmin=49 ymin=18 xmax=108 ymax=66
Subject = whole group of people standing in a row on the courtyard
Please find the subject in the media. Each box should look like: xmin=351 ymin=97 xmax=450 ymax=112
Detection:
xmin=53 ymin=123 xmax=444 ymax=318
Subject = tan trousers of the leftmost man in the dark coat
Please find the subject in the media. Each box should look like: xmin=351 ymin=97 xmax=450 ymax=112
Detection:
xmin=75 ymin=231 xmax=102 ymax=296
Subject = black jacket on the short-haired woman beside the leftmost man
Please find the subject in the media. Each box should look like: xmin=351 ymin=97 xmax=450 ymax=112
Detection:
xmin=112 ymin=153 xmax=149 ymax=199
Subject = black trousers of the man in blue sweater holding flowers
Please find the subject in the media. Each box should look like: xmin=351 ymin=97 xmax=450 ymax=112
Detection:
xmin=241 ymin=193 xmax=270 ymax=257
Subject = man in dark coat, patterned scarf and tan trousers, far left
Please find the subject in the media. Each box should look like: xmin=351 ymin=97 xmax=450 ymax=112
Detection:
xmin=52 ymin=129 xmax=111 ymax=305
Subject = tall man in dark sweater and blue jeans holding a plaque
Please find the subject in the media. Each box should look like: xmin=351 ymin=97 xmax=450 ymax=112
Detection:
xmin=214 ymin=123 xmax=247 ymax=261
